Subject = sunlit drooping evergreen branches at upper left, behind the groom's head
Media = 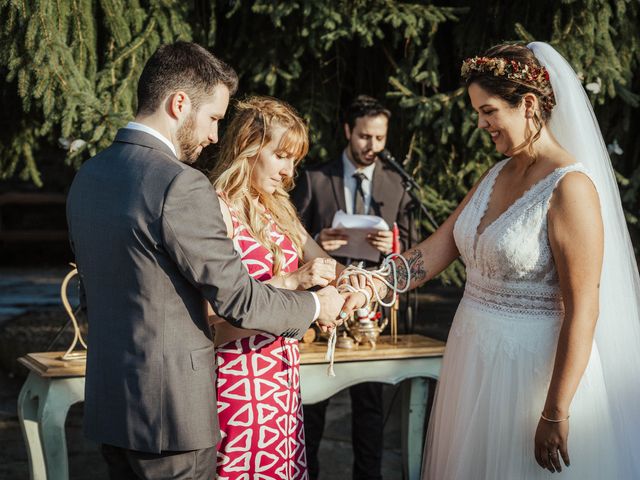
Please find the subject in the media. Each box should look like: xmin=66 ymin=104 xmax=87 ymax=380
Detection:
xmin=0 ymin=0 xmax=191 ymax=184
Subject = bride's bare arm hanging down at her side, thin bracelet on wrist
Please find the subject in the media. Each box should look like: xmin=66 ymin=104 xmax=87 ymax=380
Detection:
xmin=536 ymin=172 xmax=604 ymax=471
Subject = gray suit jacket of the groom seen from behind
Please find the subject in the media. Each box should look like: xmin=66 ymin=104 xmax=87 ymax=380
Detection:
xmin=67 ymin=129 xmax=315 ymax=453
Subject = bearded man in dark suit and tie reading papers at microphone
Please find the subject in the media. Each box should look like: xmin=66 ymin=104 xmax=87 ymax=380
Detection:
xmin=292 ymin=95 xmax=416 ymax=480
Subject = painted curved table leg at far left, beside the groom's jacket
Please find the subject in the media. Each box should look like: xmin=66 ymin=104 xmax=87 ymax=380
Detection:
xmin=18 ymin=373 xmax=84 ymax=480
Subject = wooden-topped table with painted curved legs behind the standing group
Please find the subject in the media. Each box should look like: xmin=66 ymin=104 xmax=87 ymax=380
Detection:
xmin=18 ymin=335 xmax=444 ymax=480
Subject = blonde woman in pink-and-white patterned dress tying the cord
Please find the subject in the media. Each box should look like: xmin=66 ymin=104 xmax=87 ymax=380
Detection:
xmin=212 ymin=97 xmax=362 ymax=480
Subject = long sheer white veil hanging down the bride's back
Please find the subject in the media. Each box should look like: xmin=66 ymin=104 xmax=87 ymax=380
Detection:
xmin=527 ymin=42 xmax=640 ymax=478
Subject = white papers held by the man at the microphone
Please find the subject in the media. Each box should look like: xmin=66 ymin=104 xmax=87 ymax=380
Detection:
xmin=331 ymin=210 xmax=389 ymax=262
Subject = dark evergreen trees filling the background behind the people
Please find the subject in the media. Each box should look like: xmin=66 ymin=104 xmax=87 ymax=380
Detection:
xmin=0 ymin=0 xmax=640 ymax=283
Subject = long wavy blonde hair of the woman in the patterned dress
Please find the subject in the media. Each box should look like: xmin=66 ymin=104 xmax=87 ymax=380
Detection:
xmin=210 ymin=96 xmax=309 ymax=276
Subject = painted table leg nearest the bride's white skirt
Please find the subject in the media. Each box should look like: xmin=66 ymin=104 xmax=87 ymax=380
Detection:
xmin=401 ymin=377 xmax=429 ymax=480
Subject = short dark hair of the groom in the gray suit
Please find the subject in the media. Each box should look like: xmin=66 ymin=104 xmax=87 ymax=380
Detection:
xmin=138 ymin=42 xmax=238 ymax=114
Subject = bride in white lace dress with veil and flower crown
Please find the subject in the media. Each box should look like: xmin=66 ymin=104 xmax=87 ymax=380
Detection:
xmin=360 ymin=43 xmax=640 ymax=480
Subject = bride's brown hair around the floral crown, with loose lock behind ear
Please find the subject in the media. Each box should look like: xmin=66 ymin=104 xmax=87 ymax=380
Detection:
xmin=466 ymin=43 xmax=553 ymax=160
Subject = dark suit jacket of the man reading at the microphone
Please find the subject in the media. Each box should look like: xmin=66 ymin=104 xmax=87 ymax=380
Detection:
xmin=291 ymin=158 xmax=418 ymax=260
